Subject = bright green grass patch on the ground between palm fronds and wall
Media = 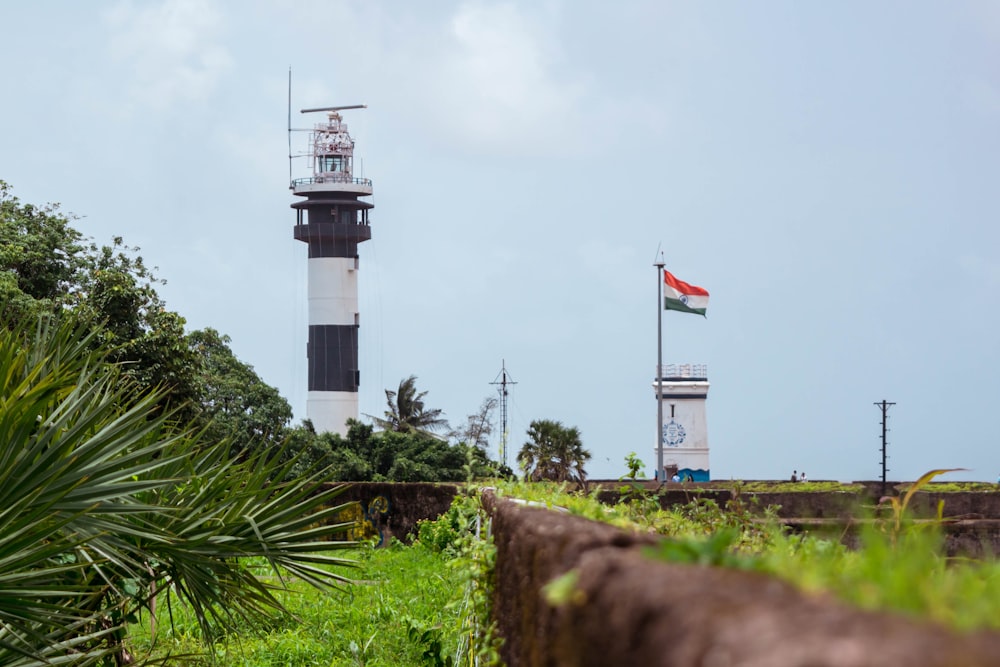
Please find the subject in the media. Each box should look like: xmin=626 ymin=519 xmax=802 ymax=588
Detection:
xmin=128 ymin=543 xmax=463 ymax=667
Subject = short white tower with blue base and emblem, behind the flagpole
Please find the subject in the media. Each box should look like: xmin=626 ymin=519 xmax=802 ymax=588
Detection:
xmin=653 ymin=364 xmax=710 ymax=482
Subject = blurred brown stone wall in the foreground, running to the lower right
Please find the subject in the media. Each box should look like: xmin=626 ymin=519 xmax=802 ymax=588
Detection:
xmin=484 ymin=493 xmax=1000 ymax=667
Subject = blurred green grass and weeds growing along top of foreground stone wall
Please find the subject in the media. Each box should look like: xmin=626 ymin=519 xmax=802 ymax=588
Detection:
xmin=498 ymin=471 xmax=1000 ymax=630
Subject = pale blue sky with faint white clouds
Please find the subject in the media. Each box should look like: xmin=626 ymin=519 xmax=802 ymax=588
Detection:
xmin=0 ymin=0 xmax=1000 ymax=480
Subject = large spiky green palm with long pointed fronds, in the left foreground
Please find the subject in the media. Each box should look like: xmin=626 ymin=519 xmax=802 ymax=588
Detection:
xmin=0 ymin=323 xmax=358 ymax=666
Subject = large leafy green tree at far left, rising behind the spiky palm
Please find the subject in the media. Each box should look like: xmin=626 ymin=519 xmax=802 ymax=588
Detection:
xmin=0 ymin=181 xmax=198 ymax=422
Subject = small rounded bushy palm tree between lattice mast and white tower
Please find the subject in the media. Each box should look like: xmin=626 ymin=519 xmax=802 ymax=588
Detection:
xmin=517 ymin=419 xmax=590 ymax=483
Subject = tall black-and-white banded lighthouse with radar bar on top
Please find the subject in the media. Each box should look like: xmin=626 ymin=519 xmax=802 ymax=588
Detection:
xmin=290 ymin=105 xmax=374 ymax=435
